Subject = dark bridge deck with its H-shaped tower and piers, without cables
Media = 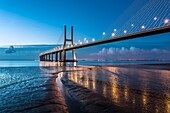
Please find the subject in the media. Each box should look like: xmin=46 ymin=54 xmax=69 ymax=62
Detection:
xmin=40 ymin=25 xmax=170 ymax=65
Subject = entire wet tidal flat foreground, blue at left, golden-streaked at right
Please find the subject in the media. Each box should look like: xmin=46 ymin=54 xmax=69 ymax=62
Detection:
xmin=0 ymin=64 xmax=170 ymax=113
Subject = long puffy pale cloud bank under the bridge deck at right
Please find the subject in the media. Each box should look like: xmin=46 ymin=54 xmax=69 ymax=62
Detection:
xmin=90 ymin=47 xmax=170 ymax=56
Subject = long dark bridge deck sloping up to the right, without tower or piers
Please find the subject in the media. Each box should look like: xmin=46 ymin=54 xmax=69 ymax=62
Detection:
xmin=40 ymin=25 xmax=170 ymax=56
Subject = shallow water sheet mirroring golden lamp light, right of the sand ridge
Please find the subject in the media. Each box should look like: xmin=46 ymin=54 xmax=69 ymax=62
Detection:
xmin=64 ymin=67 xmax=170 ymax=113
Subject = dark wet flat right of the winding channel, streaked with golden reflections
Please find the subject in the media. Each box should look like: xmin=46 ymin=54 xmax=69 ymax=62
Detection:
xmin=52 ymin=65 xmax=170 ymax=113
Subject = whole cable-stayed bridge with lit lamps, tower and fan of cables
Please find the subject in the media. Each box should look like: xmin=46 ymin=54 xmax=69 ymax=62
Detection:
xmin=40 ymin=0 xmax=170 ymax=65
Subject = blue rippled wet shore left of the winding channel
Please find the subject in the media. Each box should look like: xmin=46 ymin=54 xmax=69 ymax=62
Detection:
xmin=0 ymin=67 xmax=68 ymax=113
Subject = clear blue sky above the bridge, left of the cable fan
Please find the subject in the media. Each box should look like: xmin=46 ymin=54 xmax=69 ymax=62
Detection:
xmin=0 ymin=0 xmax=147 ymax=45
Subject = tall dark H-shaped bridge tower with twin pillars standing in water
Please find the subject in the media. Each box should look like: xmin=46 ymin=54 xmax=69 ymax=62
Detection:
xmin=61 ymin=25 xmax=77 ymax=66
